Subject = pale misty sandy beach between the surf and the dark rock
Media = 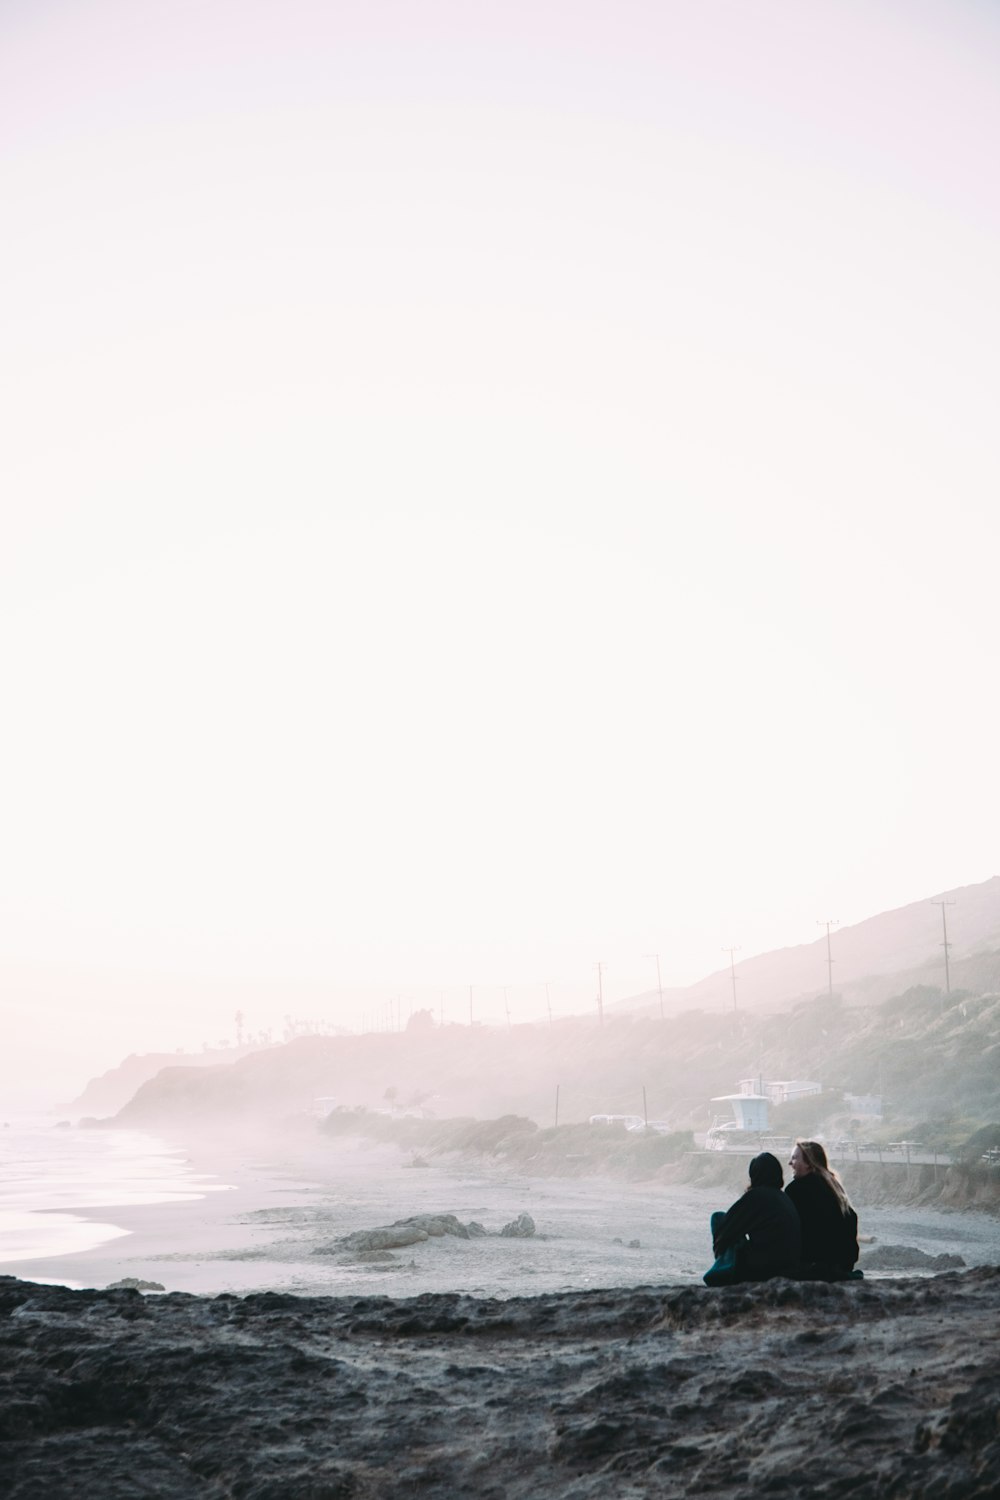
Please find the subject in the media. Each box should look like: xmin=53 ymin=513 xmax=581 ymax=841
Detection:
xmin=7 ymin=1128 xmax=1000 ymax=1298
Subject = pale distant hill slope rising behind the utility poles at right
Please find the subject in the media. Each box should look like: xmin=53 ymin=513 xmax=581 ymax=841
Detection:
xmin=615 ymin=876 xmax=1000 ymax=1014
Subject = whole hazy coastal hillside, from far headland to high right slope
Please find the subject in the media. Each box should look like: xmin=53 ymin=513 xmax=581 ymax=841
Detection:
xmin=78 ymin=876 xmax=1000 ymax=1139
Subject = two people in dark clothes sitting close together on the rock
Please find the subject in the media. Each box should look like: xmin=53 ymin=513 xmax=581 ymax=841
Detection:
xmin=703 ymin=1140 xmax=861 ymax=1287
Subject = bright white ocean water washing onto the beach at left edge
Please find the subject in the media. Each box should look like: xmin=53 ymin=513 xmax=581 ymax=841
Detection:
xmin=0 ymin=1115 xmax=226 ymax=1272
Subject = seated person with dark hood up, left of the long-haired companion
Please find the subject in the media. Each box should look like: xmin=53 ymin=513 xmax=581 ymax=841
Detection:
xmin=703 ymin=1151 xmax=802 ymax=1287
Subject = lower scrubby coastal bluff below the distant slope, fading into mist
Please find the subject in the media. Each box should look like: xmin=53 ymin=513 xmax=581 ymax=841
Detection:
xmin=115 ymin=986 xmax=1000 ymax=1149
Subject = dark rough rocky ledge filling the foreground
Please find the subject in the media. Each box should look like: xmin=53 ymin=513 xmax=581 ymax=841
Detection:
xmin=0 ymin=1268 xmax=1000 ymax=1500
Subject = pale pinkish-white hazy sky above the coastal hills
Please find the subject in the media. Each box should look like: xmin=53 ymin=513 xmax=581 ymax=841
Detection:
xmin=0 ymin=0 xmax=1000 ymax=1086
